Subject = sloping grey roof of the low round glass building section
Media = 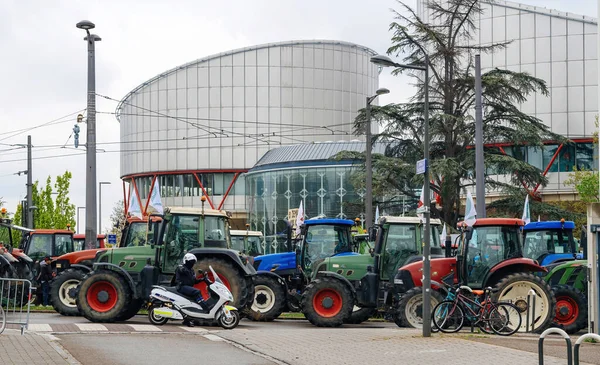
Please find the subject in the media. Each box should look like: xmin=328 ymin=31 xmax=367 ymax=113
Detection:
xmin=250 ymin=141 xmax=386 ymax=172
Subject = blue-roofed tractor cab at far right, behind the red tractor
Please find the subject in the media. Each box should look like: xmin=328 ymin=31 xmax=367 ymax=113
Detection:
xmin=523 ymin=219 xmax=583 ymax=266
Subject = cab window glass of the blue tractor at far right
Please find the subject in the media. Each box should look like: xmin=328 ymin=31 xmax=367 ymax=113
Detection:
xmin=524 ymin=229 xmax=575 ymax=262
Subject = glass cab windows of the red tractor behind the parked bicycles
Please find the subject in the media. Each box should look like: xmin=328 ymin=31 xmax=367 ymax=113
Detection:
xmin=461 ymin=226 xmax=521 ymax=288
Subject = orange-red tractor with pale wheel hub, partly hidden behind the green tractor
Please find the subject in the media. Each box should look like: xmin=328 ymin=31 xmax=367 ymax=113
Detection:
xmin=50 ymin=217 xmax=160 ymax=316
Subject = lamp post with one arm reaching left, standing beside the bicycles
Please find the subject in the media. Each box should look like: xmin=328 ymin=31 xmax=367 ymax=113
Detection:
xmin=371 ymin=52 xmax=431 ymax=337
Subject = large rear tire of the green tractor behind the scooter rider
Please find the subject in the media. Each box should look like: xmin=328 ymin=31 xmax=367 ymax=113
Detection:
xmin=194 ymin=257 xmax=254 ymax=311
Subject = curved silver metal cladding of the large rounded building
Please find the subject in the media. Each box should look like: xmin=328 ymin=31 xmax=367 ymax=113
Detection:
xmin=117 ymin=40 xmax=378 ymax=176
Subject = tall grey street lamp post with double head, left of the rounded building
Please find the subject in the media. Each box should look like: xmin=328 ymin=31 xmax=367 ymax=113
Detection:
xmin=76 ymin=20 xmax=102 ymax=249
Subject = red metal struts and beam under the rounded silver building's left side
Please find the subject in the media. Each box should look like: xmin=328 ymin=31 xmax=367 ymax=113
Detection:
xmin=121 ymin=169 xmax=248 ymax=216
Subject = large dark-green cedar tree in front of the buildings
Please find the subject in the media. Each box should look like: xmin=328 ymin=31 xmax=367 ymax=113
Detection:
xmin=336 ymin=0 xmax=566 ymax=227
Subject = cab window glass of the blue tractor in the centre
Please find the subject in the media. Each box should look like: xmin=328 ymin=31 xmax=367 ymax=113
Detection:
xmin=304 ymin=224 xmax=352 ymax=268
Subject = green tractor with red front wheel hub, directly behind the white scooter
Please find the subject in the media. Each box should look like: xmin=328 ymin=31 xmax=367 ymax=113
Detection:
xmin=77 ymin=208 xmax=256 ymax=322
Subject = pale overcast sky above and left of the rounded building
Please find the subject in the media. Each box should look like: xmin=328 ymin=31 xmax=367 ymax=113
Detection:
xmin=0 ymin=0 xmax=597 ymax=232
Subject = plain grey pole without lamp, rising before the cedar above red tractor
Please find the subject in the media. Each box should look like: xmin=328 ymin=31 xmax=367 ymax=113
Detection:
xmin=475 ymin=55 xmax=485 ymax=218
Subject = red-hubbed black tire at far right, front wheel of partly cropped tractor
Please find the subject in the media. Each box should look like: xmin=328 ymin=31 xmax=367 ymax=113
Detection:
xmin=552 ymin=285 xmax=588 ymax=334
